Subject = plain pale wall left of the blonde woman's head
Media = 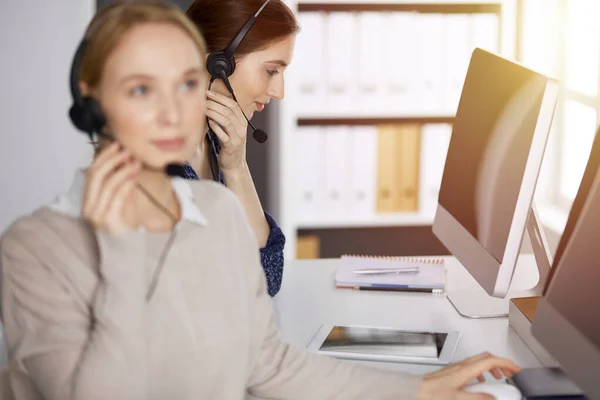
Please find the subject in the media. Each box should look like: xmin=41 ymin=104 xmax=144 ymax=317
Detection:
xmin=0 ymin=0 xmax=95 ymax=234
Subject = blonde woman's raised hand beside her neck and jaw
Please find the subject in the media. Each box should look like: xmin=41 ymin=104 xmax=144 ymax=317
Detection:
xmin=83 ymin=142 xmax=140 ymax=233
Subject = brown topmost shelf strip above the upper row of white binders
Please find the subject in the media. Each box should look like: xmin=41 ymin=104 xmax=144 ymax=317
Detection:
xmin=298 ymin=1 xmax=502 ymax=14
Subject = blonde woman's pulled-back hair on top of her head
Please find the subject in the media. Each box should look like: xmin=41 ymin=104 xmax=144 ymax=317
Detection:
xmin=78 ymin=0 xmax=206 ymax=88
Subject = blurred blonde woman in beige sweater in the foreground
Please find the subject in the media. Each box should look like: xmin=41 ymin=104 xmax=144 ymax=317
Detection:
xmin=0 ymin=1 xmax=518 ymax=400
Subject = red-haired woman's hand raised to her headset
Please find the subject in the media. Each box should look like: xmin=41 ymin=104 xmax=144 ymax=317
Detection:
xmin=206 ymin=91 xmax=248 ymax=173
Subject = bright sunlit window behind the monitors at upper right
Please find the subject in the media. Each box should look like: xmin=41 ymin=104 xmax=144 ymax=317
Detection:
xmin=519 ymin=0 xmax=600 ymax=212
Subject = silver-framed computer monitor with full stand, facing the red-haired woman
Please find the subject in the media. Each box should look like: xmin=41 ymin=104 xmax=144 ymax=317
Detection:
xmin=433 ymin=48 xmax=558 ymax=318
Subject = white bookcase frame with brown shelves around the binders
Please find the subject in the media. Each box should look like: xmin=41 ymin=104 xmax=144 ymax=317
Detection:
xmin=268 ymin=0 xmax=516 ymax=259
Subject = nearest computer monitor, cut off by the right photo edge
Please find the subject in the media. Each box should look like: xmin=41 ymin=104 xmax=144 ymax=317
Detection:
xmin=531 ymin=129 xmax=600 ymax=399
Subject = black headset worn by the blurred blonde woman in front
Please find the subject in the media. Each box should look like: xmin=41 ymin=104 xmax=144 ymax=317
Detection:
xmin=69 ymin=38 xmax=185 ymax=177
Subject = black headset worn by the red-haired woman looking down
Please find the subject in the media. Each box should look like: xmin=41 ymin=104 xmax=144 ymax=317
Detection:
xmin=206 ymin=0 xmax=271 ymax=143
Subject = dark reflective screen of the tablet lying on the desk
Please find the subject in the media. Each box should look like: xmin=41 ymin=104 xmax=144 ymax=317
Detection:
xmin=320 ymin=326 xmax=448 ymax=358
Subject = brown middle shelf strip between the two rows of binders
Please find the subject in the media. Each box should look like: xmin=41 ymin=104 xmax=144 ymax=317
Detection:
xmin=297 ymin=115 xmax=454 ymax=126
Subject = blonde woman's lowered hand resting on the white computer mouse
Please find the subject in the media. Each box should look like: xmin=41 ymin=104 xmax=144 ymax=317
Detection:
xmin=418 ymin=353 xmax=521 ymax=400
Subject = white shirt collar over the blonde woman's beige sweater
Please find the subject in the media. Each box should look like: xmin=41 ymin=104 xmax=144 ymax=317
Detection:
xmin=49 ymin=169 xmax=208 ymax=226
